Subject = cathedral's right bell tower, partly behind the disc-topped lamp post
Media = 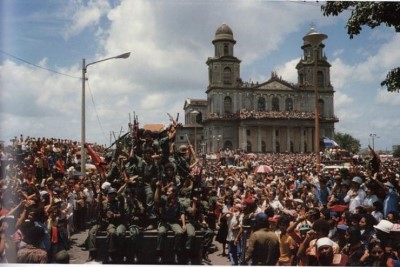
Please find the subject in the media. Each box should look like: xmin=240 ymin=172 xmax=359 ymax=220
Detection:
xmin=296 ymin=27 xmax=333 ymax=91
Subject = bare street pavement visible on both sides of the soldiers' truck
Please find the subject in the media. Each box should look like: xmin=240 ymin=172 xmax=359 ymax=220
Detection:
xmin=68 ymin=230 xmax=230 ymax=265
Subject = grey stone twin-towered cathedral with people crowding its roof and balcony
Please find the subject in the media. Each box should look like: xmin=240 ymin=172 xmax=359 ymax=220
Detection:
xmin=180 ymin=24 xmax=339 ymax=153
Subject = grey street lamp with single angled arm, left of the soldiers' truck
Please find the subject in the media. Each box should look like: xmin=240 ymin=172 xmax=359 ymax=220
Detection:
xmin=81 ymin=52 xmax=131 ymax=177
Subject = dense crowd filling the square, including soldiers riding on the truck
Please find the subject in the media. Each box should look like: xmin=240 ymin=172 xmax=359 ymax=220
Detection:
xmin=0 ymin=123 xmax=400 ymax=266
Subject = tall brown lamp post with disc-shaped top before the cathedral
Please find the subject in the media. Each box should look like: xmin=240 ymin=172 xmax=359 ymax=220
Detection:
xmin=303 ymin=28 xmax=328 ymax=172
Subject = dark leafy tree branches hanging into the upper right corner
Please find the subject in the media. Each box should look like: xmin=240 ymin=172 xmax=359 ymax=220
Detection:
xmin=321 ymin=1 xmax=400 ymax=92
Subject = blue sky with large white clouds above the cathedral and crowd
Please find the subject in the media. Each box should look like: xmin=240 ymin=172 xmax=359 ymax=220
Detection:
xmin=0 ymin=0 xmax=400 ymax=150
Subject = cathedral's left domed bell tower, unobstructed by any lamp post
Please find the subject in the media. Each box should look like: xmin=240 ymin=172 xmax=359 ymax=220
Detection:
xmin=206 ymin=24 xmax=240 ymax=89
